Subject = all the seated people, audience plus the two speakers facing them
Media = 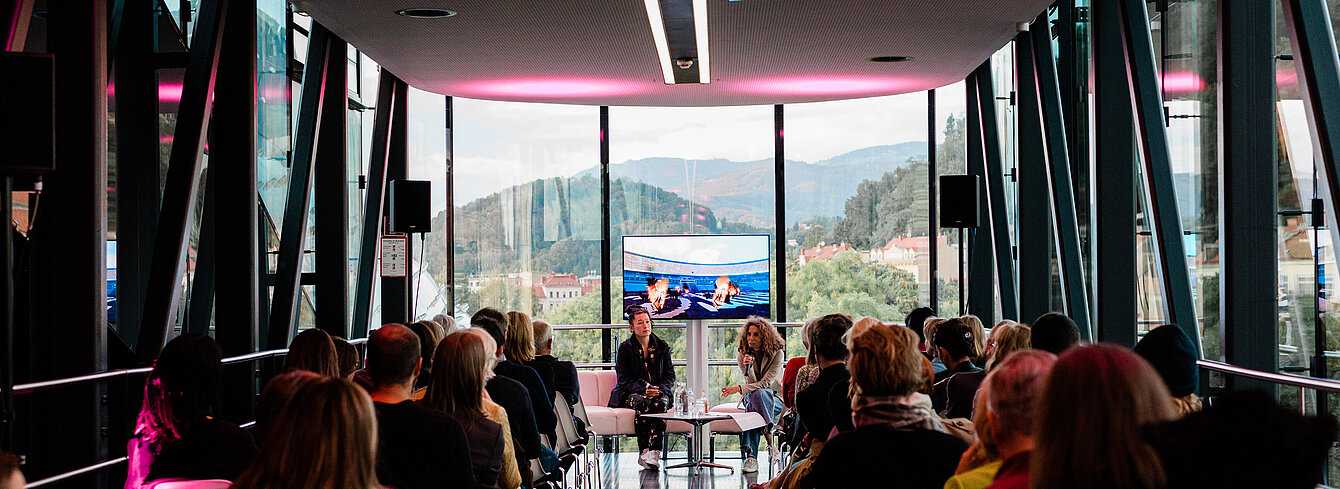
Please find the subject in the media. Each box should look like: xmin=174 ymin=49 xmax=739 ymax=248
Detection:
xmin=0 ymin=302 xmax=1337 ymax=489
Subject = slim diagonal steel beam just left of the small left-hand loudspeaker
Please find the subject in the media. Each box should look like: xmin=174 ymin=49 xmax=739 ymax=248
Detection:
xmin=348 ymin=68 xmax=405 ymax=338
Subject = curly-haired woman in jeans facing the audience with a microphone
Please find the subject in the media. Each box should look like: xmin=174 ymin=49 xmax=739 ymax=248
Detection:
xmin=721 ymin=316 xmax=787 ymax=473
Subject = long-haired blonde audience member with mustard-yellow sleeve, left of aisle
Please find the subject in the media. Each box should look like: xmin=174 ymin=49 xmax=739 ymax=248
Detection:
xmin=423 ymin=330 xmax=521 ymax=488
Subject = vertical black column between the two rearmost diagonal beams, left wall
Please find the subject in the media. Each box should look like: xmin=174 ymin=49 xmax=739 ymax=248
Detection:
xmin=312 ymin=35 xmax=348 ymax=338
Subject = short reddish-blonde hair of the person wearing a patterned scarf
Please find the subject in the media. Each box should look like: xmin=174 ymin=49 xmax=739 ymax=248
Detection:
xmin=847 ymin=318 xmax=925 ymax=401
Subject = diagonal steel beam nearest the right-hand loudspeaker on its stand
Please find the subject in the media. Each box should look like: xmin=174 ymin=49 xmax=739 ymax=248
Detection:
xmin=977 ymin=59 xmax=1018 ymax=322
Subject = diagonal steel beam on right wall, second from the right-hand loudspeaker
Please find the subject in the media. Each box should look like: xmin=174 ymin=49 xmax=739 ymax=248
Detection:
xmin=1025 ymin=12 xmax=1093 ymax=340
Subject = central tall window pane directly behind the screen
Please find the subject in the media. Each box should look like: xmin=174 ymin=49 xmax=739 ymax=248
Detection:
xmin=608 ymin=106 xmax=777 ymax=403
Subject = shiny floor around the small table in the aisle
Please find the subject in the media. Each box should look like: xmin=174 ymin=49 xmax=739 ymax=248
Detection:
xmin=578 ymin=447 xmax=776 ymax=489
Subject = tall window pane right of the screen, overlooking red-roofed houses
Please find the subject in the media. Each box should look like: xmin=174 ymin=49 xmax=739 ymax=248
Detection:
xmin=787 ymin=92 xmax=932 ymax=328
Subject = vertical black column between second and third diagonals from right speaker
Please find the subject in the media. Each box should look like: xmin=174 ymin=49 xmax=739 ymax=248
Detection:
xmin=1091 ymin=1 xmax=1136 ymax=347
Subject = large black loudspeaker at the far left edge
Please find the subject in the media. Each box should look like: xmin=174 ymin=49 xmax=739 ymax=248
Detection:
xmin=0 ymin=52 xmax=56 ymax=174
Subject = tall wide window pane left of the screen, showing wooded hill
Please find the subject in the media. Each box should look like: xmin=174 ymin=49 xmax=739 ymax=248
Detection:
xmin=452 ymin=98 xmax=600 ymax=324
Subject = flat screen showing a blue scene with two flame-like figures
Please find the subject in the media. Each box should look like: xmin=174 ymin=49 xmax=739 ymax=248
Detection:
xmin=623 ymin=234 xmax=772 ymax=319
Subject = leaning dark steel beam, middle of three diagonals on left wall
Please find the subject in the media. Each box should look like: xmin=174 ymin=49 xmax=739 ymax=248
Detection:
xmin=269 ymin=21 xmax=330 ymax=348
